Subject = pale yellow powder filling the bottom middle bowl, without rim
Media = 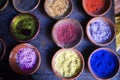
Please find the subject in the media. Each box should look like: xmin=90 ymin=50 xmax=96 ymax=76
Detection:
xmin=55 ymin=50 xmax=81 ymax=77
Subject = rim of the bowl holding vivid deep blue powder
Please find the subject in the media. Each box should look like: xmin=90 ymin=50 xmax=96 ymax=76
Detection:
xmin=87 ymin=47 xmax=120 ymax=80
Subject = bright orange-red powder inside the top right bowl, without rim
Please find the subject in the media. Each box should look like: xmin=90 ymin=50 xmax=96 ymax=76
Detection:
xmin=86 ymin=0 xmax=106 ymax=14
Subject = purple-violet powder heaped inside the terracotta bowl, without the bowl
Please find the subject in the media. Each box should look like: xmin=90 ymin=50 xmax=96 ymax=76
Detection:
xmin=16 ymin=48 xmax=36 ymax=71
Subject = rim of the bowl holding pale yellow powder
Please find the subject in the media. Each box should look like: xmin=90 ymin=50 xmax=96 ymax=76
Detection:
xmin=51 ymin=48 xmax=85 ymax=80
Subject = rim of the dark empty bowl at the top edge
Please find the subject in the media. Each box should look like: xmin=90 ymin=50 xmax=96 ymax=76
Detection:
xmin=12 ymin=0 xmax=41 ymax=13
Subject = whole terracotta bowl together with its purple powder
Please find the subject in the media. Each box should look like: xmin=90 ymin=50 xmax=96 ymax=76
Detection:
xmin=9 ymin=43 xmax=41 ymax=76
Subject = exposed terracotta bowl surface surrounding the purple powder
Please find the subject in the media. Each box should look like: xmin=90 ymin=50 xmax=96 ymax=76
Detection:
xmin=9 ymin=43 xmax=41 ymax=75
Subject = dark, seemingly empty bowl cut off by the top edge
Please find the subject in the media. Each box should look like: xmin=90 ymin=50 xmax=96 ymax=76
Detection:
xmin=12 ymin=0 xmax=40 ymax=13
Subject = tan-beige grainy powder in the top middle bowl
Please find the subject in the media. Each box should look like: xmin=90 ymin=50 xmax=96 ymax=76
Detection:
xmin=47 ymin=0 xmax=70 ymax=17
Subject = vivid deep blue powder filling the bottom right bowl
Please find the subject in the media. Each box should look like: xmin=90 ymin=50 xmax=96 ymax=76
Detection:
xmin=90 ymin=50 xmax=119 ymax=79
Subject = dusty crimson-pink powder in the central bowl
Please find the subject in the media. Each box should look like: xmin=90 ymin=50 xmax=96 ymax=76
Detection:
xmin=56 ymin=24 xmax=80 ymax=45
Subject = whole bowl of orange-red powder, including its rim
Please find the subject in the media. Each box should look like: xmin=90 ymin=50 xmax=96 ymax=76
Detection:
xmin=82 ymin=0 xmax=112 ymax=17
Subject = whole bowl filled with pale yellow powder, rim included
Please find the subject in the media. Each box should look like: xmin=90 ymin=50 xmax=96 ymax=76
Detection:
xmin=52 ymin=48 xmax=85 ymax=80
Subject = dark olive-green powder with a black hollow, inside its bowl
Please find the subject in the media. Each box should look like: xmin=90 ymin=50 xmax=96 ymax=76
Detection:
xmin=12 ymin=14 xmax=38 ymax=40
